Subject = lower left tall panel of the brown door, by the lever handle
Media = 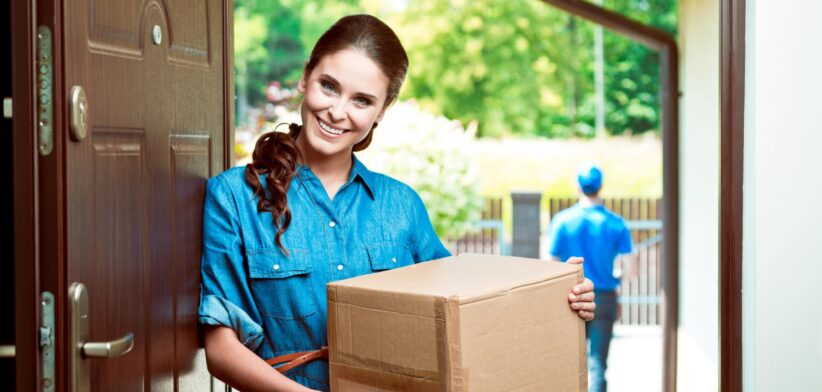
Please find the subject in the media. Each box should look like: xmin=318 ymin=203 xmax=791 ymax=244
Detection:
xmin=88 ymin=128 xmax=149 ymax=391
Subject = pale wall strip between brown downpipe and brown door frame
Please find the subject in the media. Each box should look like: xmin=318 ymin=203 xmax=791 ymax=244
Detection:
xmin=677 ymin=0 xmax=720 ymax=391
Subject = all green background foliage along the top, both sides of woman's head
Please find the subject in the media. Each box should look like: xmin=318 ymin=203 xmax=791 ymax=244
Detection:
xmin=235 ymin=0 xmax=677 ymax=137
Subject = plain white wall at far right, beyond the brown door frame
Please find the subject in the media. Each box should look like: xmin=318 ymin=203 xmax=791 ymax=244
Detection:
xmin=743 ymin=0 xmax=822 ymax=391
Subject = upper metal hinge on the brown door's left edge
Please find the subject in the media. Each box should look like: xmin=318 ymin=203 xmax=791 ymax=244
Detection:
xmin=34 ymin=26 xmax=54 ymax=155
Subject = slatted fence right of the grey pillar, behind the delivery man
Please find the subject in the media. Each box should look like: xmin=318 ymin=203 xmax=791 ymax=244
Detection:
xmin=548 ymin=199 xmax=662 ymax=325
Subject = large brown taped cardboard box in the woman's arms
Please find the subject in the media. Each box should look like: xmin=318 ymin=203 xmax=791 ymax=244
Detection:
xmin=327 ymin=254 xmax=588 ymax=392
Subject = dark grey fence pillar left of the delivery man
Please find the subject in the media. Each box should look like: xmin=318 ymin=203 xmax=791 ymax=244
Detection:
xmin=511 ymin=192 xmax=542 ymax=259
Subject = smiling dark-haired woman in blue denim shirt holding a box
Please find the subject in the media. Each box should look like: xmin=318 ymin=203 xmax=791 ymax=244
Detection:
xmin=199 ymin=15 xmax=594 ymax=391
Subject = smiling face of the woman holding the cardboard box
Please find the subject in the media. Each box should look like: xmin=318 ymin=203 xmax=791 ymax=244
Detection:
xmin=298 ymin=49 xmax=389 ymax=158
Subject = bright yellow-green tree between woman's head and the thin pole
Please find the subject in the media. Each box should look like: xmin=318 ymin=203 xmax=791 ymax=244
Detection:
xmin=392 ymin=0 xmax=591 ymax=136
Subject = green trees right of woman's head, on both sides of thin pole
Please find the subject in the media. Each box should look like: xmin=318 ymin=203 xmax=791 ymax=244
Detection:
xmin=392 ymin=0 xmax=676 ymax=137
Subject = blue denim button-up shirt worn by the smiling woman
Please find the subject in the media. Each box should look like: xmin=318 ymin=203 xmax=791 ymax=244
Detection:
xmin=199 ymin=157 xmax=450 ymax=390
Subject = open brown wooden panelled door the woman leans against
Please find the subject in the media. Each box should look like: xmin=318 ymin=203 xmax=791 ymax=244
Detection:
xmin=61 ymin=0 xmax=232 ymax=391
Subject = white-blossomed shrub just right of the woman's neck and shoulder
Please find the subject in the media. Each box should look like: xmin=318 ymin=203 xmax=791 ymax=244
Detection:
xmin=357 ymin=101 xmax=483 ymax=240
